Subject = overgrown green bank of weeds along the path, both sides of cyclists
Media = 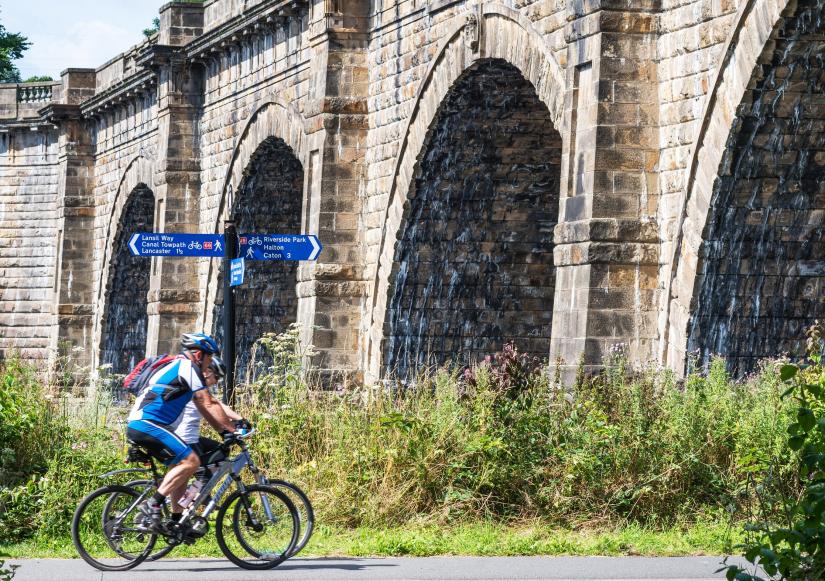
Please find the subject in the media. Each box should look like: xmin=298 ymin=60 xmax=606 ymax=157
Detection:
xmin=0 ymin=335 xmax=792 ymax=555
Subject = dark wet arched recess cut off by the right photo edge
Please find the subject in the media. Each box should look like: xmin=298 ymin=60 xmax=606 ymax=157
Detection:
xmin=687 ymin=0 xmax=825 ymax=375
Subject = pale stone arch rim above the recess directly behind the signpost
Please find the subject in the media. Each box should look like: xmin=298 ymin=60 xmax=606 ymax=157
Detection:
xmin=201 ymin=99 xmax=307 ymax=336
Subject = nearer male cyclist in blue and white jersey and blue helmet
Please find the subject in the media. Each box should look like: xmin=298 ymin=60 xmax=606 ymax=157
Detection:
xmin=126 ymin=333 xmax=235 ymax=532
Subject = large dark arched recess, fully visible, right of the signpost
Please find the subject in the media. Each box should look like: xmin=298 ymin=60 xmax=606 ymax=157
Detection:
xmin=383 ymin=59 xmax=561 ymax=378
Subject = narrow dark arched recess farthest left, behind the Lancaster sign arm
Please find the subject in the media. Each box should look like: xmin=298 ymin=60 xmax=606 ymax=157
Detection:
xmin=100 ymin=184 xmax=155 ymax=373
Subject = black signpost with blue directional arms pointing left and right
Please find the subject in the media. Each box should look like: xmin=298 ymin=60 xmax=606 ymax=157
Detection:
xmin=129 ymin=225 xmax=323 ymax=405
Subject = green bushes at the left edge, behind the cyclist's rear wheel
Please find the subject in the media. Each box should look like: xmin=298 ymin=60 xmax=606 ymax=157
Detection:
xmin=0 ymin=359 xmax=122 ymax=542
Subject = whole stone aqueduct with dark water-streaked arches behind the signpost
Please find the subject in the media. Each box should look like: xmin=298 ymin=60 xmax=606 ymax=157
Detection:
xmin=0 ymin=0 xmax=825 ymax=380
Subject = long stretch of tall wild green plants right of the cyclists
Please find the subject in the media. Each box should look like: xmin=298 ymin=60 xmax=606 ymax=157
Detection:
xmin=232 ymin=340 xmax=789 ymax=526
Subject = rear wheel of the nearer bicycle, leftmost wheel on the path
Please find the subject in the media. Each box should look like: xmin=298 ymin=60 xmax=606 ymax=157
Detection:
xmin=72 ymin=485 xmax=157 ymax=571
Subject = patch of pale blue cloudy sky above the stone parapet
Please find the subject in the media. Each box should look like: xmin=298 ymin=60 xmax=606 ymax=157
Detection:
xmin=0 ymin=0 xmax=165 ymax=79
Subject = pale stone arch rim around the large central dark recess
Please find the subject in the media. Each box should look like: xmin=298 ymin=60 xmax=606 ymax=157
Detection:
xmin=363 ymin=4 xmax=565 ymax=377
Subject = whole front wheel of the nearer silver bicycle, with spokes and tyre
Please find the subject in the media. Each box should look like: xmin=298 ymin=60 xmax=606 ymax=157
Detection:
xmin=215 ymin=484 xmax=300 ymax=569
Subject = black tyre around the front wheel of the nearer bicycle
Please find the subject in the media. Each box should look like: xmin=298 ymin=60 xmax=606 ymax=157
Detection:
xmin=215 ymin=484 xmax=300 ymax=571
